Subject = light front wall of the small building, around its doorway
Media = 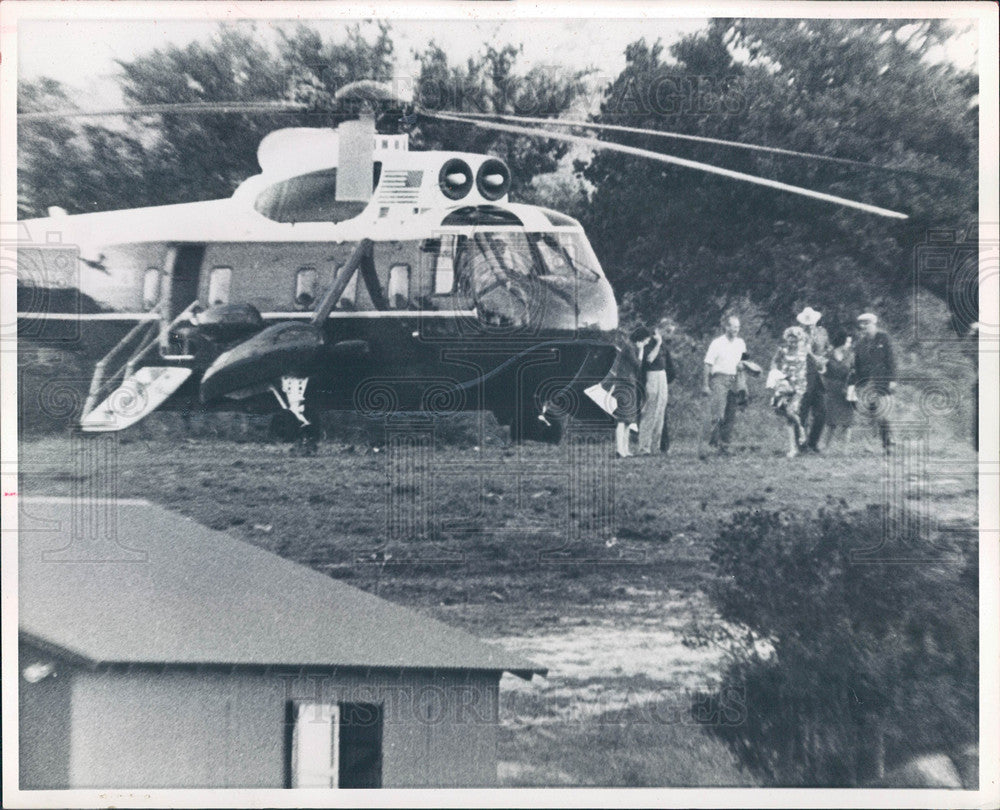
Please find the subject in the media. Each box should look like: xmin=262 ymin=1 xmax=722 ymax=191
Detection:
xmin=68 ymin=666 xmax=499 ymax=788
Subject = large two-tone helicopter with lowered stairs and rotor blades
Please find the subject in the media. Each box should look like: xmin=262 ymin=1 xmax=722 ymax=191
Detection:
xmin=18 ymin=82 xmax=906 ymax=446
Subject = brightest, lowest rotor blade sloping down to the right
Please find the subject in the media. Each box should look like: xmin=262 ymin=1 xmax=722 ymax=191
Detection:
xmin=421 ymin=111 xmax=909 ymax=219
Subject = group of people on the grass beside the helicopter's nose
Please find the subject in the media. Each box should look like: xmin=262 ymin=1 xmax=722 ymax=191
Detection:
xmin=611 ymin=307 xmax=896 ymax=459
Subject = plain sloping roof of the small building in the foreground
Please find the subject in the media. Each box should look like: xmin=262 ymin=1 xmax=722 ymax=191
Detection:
xmin=18 ymin=498 xmax=546 ymax=679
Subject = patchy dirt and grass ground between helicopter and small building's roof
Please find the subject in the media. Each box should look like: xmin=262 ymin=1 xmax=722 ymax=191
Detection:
xmin=19 ymin=416 xmax=977 ymax=786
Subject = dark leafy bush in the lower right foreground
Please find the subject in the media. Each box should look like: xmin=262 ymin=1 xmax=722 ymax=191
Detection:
xmin=697 ymin=507 xmax=979 ymax=786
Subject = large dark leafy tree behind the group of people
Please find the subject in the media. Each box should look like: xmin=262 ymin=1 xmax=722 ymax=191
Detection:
xmin=585 ymin=20 xmax=977 ymax=328
